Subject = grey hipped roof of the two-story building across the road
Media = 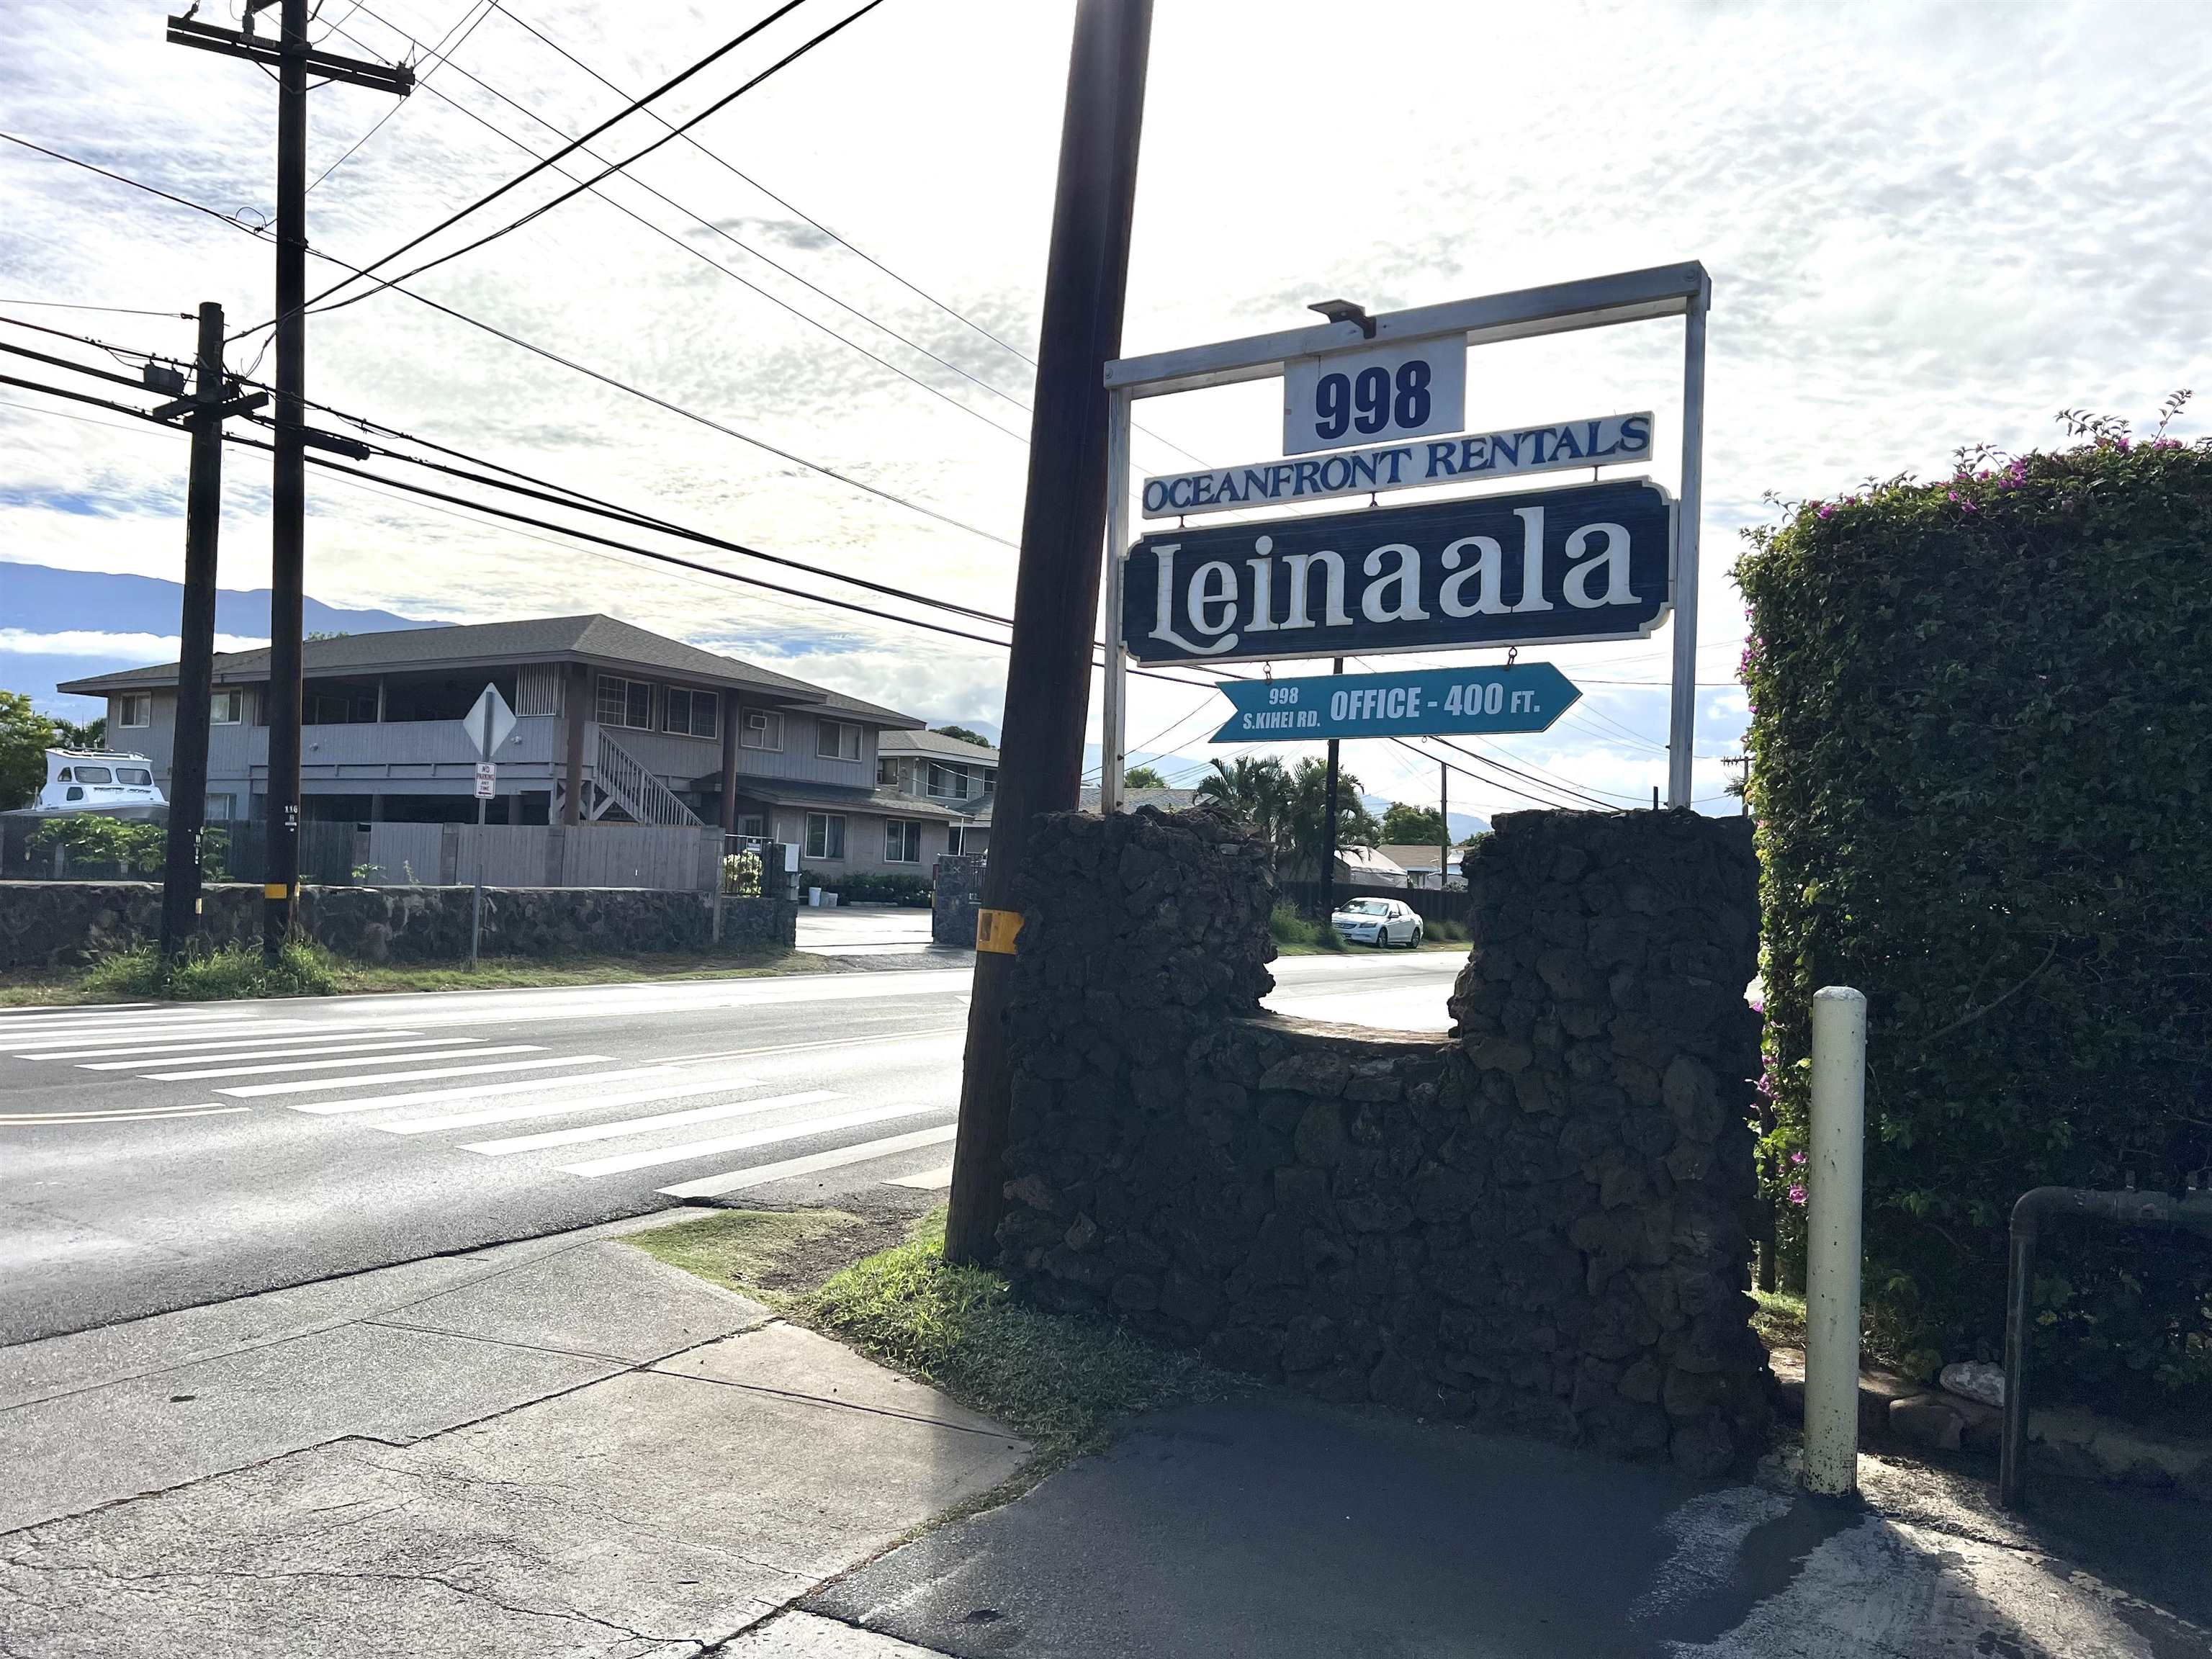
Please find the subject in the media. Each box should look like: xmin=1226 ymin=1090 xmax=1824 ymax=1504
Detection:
xmin=55 ymin=615 xmax=922 ymax=728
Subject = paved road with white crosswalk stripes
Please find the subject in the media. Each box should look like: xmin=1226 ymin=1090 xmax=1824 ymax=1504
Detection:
xmin=0 ymin=953 xmax=1455 ymax=1343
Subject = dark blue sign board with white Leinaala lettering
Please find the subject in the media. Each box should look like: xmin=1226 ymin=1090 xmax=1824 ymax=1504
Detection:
xmin=1122 ymin=478 xmax=1675 ymax=664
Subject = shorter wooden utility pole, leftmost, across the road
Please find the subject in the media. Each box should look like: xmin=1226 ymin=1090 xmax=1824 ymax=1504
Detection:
xmin=155 ymin=301 xmax=268 ymax=962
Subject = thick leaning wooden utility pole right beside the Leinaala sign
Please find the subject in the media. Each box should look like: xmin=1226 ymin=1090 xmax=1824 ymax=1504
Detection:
xmin=945 ymin=0 xmax=1153 ymax=1263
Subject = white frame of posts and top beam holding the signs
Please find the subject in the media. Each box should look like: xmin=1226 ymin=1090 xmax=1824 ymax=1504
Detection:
xmin=1100 ymin=261 xmax=1712 ymax=811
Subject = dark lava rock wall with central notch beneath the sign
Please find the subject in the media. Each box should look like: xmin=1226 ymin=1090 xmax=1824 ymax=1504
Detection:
xmin=1000 ymin=811 xmax=1770 ymax=1475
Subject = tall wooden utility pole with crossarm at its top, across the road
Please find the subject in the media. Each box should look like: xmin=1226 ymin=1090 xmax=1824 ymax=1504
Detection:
xmin=168 ymin=0 xmax=413 ymax=956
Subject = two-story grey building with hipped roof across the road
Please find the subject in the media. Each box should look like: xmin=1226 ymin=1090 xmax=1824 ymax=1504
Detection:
xmin=60 ymin=615 xmax=968 ymax=873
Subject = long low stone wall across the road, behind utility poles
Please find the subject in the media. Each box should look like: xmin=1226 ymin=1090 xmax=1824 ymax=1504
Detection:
xmin=0 ymin=881 xmax=799 ymax=969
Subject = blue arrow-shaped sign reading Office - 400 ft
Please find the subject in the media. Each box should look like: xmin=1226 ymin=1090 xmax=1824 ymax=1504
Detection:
xmin=1215 ymin=662 xmax=1581 ymax=743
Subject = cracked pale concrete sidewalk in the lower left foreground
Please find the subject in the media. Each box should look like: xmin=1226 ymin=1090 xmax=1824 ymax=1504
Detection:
xmin=0 ymin=1219 xmax=1026 ymax=1659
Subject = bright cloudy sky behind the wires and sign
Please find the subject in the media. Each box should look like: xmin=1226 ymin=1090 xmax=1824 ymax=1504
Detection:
xmin=0 ymin=0 xmax=2212 ymax=811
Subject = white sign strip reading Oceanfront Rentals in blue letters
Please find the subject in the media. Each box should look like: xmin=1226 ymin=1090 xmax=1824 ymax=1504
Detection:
xmin=1141 ymin=409 xmax=1653 ymax=518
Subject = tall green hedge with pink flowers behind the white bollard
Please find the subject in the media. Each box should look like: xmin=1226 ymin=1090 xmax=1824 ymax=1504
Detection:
xmin=1737 ymin=436 xmax=2212 ymax=1403
